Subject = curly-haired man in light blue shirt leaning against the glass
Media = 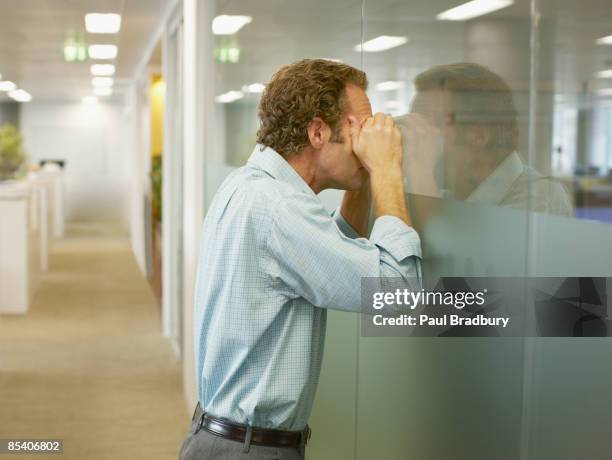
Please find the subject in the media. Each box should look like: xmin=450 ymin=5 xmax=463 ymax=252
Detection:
xmin=180 ymin=59 xmax=421 ymax=460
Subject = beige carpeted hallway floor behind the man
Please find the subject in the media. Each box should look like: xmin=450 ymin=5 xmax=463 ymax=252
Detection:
xmin=0 ymin=223 xmax=191 ymax=460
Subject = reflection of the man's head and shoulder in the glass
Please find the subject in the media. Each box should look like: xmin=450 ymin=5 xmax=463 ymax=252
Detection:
xmin=398 ymin=63 xmax=571 ymax=215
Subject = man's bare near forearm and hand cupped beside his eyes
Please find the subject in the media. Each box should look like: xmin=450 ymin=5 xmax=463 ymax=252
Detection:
xmin=349 ymin=113 xmax=410 ymax=225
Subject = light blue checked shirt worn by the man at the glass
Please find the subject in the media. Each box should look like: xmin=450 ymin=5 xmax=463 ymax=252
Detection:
xmin=194 ymin=145 xmax=421 ymax=430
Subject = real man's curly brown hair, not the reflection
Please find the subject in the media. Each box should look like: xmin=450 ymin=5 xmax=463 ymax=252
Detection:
xmin=257 ymin=59 xmax=368 ymax=156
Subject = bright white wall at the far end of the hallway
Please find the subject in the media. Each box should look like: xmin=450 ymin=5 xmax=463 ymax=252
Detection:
xmin=20 ymin=102 xmax=129 ymax=227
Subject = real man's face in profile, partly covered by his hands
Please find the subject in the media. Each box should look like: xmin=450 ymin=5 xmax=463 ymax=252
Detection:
xmin=318 ymin=84 xmax=372 ymax=190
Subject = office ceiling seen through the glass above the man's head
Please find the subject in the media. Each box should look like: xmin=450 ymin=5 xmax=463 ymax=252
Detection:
xmin=216 ymin=0 xmax=612 ymax=96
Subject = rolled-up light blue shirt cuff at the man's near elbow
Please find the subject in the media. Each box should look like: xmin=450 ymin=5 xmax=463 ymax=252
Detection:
xmin=370 ymin=216 xmax=423 ymax=262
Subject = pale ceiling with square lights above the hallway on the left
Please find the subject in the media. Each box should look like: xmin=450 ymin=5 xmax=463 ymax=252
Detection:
xmin=0 ymin=0 xmax=170 ymax=101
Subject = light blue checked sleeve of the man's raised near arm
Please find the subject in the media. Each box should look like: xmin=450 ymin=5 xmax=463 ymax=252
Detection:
xmin=264 ymin=194 xmax=422 ymax=312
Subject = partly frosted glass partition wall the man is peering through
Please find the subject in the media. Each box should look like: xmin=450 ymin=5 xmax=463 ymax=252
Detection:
xmin=205 ymin=0 xmax=612 ymax=460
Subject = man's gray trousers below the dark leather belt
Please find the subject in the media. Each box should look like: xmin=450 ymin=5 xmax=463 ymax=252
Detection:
xmin=179 ymin=418 xmax=305 ymax=460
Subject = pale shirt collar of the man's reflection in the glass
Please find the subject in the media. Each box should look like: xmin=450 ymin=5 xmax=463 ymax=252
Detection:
xmin=466 ymin=152 xmax=525 ymax=204
